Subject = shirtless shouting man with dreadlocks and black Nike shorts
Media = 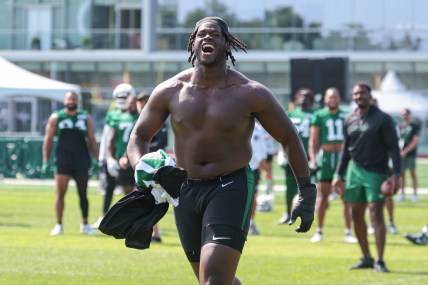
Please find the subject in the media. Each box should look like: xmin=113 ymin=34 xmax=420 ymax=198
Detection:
xmin=128 ymin=17 xmax=316 ymax=284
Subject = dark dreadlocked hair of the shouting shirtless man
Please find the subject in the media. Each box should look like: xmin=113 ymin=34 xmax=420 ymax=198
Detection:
xmin=187 ymin=17 xmax=247 ymax=66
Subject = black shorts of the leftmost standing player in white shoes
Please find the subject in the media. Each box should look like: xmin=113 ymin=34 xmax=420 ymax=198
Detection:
xmin=55 ymin=149 xmax=91 ymax=177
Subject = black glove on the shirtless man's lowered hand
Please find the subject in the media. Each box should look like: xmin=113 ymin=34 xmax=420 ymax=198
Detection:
xmin=288 ymin=177 xmax=317 ymax=233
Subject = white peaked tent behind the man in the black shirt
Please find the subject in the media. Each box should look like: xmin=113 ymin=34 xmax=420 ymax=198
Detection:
xmin=372 ymin=70 xmax=428 ymax=118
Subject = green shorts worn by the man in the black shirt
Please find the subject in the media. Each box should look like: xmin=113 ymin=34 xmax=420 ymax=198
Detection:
xmin=345 ymin=160 xmax=388 ymax=203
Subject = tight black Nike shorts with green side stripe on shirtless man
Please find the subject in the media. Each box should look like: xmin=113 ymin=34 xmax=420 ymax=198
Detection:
xmin=174 ymin=166 xmax=254 ymax=262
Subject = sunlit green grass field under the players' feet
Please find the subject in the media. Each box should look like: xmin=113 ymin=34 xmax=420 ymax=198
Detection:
xmin=0 ymin=159 xmax=428 ymax=285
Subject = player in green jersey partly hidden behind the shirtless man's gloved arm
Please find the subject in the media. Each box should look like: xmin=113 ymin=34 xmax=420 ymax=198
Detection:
xmin=277 ymin=88 xmax=314 ymax=225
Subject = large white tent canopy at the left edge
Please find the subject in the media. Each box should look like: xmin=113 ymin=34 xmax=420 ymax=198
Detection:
xmin=0 ymin=57 xmax=80 ymax=102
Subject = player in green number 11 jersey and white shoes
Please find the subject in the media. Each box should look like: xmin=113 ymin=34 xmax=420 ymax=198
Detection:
xmin=309 ymin=87 xmax=357 ymax=243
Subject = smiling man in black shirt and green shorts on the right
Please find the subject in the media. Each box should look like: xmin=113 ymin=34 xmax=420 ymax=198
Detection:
xmin=332 ymin=83 xmax=401 ymax=272
